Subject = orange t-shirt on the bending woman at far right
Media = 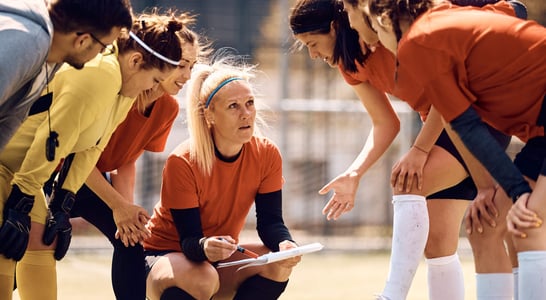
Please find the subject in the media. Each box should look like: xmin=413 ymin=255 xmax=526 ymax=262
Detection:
xmin=394 ymin=4 xmax=546 ymax=141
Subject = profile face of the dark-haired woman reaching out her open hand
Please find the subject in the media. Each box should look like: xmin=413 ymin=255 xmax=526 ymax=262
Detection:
xmin=294 ymin=28 xmax=337 ymax=67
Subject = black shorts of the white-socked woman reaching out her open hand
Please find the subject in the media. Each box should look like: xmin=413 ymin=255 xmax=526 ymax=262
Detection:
xmin=427 ymin=125 xmax=511 ymax=200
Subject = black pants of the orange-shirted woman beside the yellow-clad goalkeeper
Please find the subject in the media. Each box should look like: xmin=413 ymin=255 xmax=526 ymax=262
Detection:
xmin=71 ymin=185 xmax=146 ymax=300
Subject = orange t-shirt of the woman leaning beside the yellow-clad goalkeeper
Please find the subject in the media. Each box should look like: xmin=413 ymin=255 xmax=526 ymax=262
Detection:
xmin=97 ymin=94 xmax=179 ymax=172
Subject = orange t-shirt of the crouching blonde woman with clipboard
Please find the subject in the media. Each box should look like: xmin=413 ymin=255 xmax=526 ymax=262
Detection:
xmin=144 ymin=137 xmax=283 ymax=251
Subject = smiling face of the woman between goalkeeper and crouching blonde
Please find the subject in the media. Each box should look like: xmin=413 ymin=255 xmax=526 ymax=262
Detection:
xmin=160 ymin=42 xmax=198 ymax=95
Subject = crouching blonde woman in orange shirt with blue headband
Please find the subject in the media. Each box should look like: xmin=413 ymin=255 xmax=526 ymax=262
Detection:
xmin=144 ymin=56 xmax=300 ymax=300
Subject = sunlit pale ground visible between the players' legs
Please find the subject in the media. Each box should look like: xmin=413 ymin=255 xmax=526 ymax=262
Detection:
xmin=10 ymin=251 xmax=475 ymax=300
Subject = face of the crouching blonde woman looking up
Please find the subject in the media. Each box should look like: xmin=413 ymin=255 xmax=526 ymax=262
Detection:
xmin=206 ymin=80 xmax=256 ymax=157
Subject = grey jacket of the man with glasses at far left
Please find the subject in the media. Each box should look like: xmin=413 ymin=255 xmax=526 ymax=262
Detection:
xmin=0 ymin=0 xmax=53 ymax=151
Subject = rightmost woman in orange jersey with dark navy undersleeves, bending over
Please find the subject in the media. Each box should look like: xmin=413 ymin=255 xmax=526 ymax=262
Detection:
xmin=363 ymin=0 xmax=546 ymax=299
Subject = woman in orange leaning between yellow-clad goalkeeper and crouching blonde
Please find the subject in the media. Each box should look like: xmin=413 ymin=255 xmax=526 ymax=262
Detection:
xmin=65 ymin=14 xmax=206 ymax=300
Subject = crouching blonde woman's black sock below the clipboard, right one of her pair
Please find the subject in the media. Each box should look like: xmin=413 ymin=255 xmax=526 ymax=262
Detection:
xmin=233 ymin=275 xmax=288 ymax=300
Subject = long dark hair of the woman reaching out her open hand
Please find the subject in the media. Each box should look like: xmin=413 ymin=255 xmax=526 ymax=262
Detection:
xmin=290 ymin=0 xmax=369 ymax=73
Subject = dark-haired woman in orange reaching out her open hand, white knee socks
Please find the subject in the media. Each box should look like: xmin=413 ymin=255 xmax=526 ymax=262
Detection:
xmin=290 ymin=0 xmax=524 ymax=299
